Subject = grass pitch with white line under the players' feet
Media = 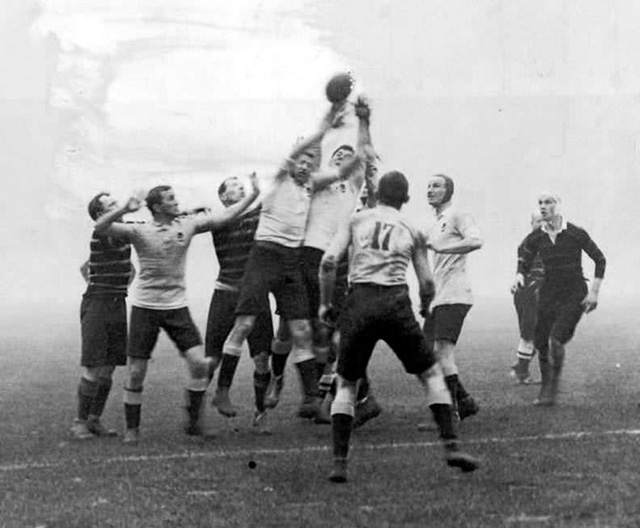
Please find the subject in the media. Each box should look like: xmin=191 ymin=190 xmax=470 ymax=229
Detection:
xmin=0 ymin=299 xmax=640 ymax=528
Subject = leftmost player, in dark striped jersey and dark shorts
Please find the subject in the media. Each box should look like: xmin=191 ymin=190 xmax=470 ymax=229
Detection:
xmin=71 ymin=192 xmax=135 ymax=440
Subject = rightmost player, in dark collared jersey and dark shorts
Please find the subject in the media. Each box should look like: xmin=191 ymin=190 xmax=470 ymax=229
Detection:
xmin=516 ymin=192 xmax=607 ymax=406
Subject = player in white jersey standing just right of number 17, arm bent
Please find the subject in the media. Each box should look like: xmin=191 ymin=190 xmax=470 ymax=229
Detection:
xmin=423 ymin=174 xmax=483 ymax=420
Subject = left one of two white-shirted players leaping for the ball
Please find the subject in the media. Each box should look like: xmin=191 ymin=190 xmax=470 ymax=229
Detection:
xmin=223 ymin=105 xmax=359 ymax=418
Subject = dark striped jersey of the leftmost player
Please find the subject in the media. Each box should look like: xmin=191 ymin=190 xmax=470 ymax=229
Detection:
xmin=85 ymin=232 xmax=132 ymax=296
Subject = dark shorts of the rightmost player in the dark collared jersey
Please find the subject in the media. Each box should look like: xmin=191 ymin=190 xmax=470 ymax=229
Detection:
xmin=534 ymin=284 xmax=587 ymax=351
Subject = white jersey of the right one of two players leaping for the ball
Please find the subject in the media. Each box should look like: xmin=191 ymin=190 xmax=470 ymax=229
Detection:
xmin=304 ymin=171 xmax=364 ymax=251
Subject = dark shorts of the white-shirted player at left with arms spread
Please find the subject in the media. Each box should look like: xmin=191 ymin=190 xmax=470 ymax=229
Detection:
xmin=127 ymin=306 xmax=202 ymax=359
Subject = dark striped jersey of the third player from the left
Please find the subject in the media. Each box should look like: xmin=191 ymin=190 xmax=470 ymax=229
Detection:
xmin=211 ymin=207 xmax=261 ymax=291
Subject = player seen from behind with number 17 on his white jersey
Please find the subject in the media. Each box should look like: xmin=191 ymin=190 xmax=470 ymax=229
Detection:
xmin=318 ymin=171 xmax=479 ymax=482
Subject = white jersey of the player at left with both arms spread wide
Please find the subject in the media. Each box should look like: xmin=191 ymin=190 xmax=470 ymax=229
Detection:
xmin=109 ymin=215 xmax=207 ymax=310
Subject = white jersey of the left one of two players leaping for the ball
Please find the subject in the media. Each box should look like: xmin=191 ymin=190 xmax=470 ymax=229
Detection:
xmin=255 ymin=174 xmax=311 ymax=247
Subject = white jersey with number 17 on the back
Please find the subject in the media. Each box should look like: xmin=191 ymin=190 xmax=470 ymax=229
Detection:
xmin=349 ymin=205 xmax=422 ymax=286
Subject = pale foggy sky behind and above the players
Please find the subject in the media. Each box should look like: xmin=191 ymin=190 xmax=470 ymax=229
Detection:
xmin=0 ymin=0 xmax=640 ymax=342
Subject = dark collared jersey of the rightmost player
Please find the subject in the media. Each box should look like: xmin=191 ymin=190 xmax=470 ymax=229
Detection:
xmin=518 ymin=222 xmax=607 ymax=289
